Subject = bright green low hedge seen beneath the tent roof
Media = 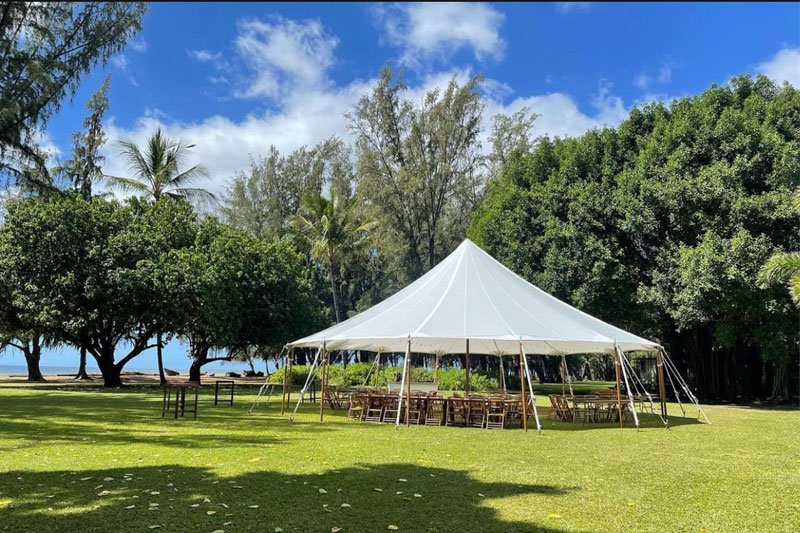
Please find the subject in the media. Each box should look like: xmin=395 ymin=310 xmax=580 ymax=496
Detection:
xmin=270 ymin=363 xmax=500 ymax=391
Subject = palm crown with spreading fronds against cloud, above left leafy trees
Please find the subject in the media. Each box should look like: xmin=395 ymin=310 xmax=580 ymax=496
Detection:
xmin=106 ymin=128 xmax=216 ymax=203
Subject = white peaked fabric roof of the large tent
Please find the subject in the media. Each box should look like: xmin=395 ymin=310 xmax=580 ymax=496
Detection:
xmin=289 ymin=239 xmax=658 ymax=354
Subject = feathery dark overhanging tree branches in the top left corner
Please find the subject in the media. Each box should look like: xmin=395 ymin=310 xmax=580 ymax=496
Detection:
xmin=0 ymin=2 xmax=147 ymax=190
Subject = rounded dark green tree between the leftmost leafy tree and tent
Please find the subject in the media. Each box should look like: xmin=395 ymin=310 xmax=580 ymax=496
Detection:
xmin=147 ymin=219 xmax=322 ymax=382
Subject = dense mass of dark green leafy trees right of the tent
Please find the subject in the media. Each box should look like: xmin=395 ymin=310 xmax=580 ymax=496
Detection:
xmin=469 ymin=77 xmax=800 ymax=400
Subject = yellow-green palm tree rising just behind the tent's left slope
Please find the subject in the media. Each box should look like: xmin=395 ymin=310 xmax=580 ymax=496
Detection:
xmin=287 ymin=193 xmax=376 ymax=322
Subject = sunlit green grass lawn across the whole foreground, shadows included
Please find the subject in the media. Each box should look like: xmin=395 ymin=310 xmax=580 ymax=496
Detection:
xmin=0 ymin=387 xmax=800 ymax=532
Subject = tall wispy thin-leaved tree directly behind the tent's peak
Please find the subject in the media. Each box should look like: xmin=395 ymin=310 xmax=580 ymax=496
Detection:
xmin=347 ymin=67 xmax=484 ymax=282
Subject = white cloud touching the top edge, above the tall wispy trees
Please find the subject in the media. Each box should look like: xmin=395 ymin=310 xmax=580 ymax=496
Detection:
xmin=373 ymin=2 xmax=505 ymax=68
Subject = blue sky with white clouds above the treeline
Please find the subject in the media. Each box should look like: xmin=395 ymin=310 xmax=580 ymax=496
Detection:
xmin=0 ymin=2 xmax=800 ymax=367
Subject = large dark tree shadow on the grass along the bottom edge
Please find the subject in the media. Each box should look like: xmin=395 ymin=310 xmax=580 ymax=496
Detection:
xmin=0 ymin=464 xmax=574 ymax=533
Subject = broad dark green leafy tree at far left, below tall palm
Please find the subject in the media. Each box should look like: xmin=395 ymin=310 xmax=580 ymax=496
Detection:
xmin=0 ymin=194 xmax=196 ymax=386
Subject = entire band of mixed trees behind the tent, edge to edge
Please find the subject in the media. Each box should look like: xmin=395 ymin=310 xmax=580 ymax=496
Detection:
xmin=0 ymin=2 xmax=800 ymax=401
